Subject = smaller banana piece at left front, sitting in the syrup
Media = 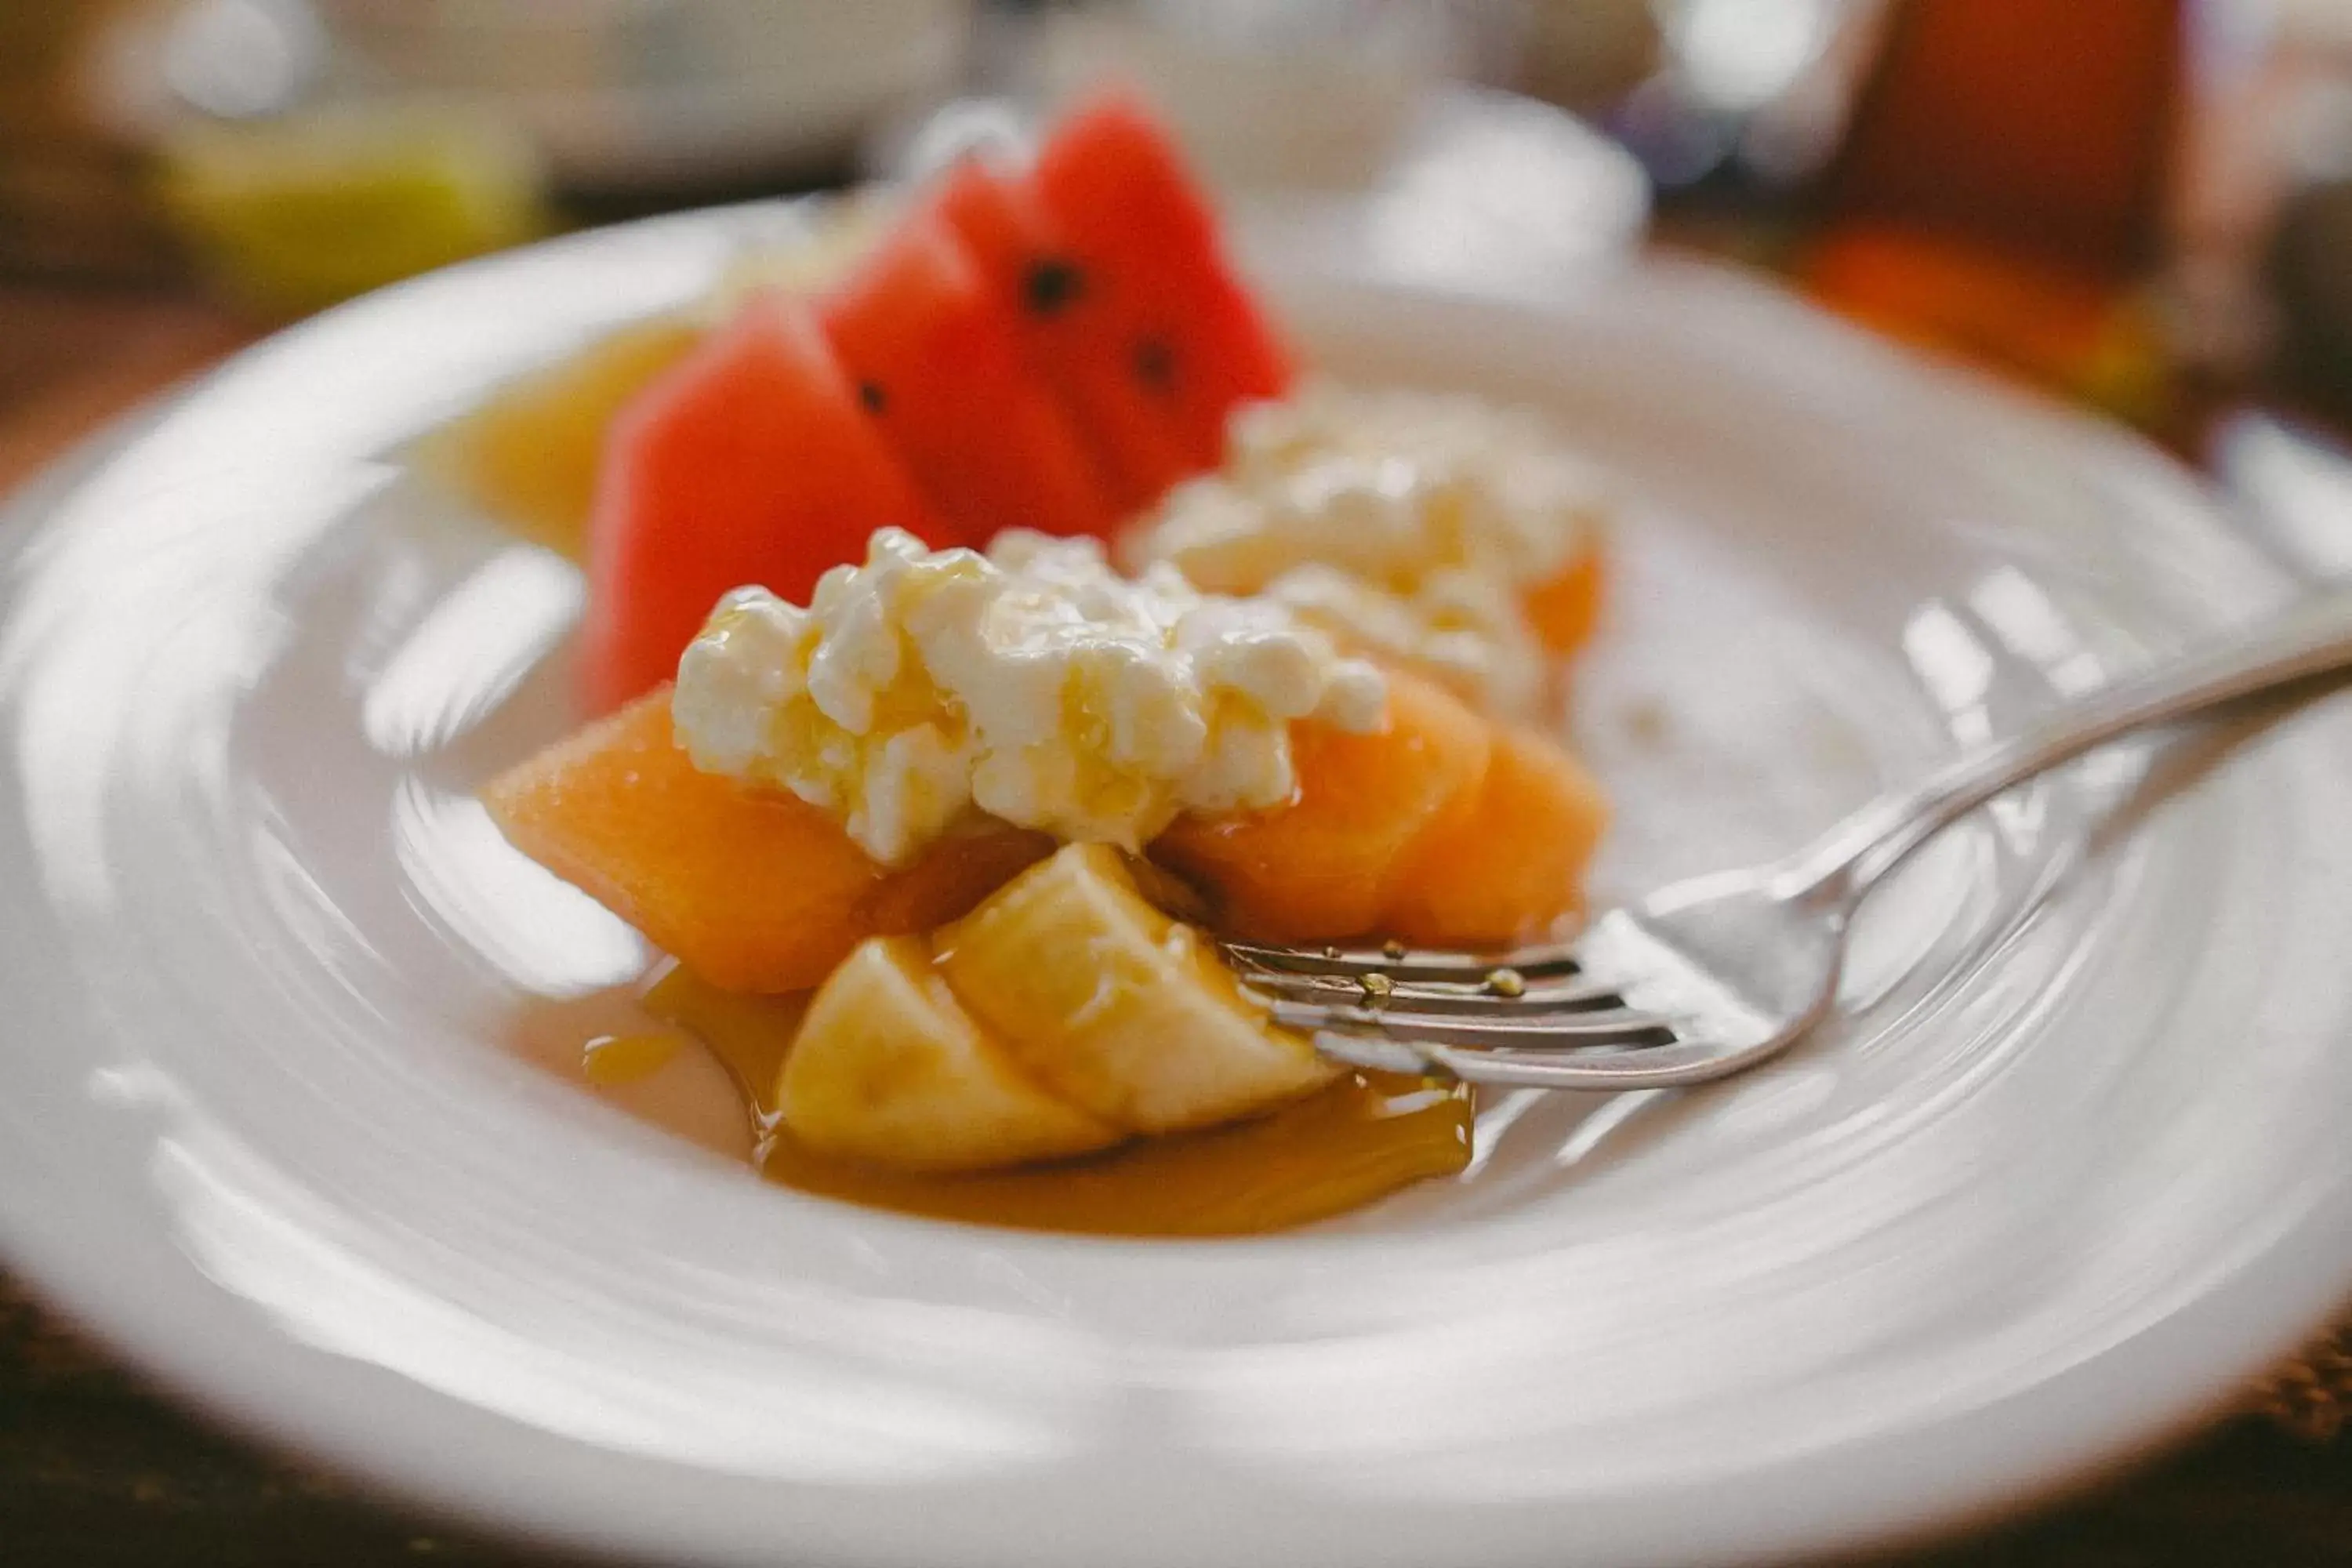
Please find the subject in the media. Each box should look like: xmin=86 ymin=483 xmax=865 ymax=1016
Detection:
xmin=776 ymin=935 xmax=1124 ymax=1171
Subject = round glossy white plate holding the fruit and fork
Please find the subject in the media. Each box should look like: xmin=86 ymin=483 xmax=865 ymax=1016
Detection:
xmin=0 ymin=209 xmax=2352 ymax=1568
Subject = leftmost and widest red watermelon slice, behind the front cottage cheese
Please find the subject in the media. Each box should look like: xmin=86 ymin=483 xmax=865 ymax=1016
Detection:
xmin=581 ymin=299 xmax=957 ymax=713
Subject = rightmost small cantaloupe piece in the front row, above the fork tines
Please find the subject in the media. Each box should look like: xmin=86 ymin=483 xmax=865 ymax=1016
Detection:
xmin=1381 ymin=727 xmax=1609 ymax=947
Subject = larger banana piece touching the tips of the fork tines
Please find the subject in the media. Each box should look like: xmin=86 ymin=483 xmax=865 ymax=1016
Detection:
xmin=936 ymin=844 xmax=1336 ymax=1133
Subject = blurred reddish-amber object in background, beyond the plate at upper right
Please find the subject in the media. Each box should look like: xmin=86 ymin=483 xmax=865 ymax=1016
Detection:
xmin=1797 ymin=0 xmax=2185 ymax=426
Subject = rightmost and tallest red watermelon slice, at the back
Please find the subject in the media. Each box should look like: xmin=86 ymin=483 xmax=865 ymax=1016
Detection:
xmin=1030 ymin=96 xmax=1294 ymax=479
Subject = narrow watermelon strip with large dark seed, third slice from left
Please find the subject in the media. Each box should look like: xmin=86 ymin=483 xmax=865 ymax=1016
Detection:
xmin=936 ymin=160 xmax=1207 ymax=515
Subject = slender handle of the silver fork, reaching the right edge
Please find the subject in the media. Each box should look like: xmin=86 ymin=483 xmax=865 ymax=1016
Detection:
xmin=1790 ymin=590 xmax=2352 ymax=902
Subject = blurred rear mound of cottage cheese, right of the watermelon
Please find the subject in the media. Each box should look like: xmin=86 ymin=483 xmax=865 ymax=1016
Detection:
xmin=1122 ymin=381 xmax=1606 ymax=715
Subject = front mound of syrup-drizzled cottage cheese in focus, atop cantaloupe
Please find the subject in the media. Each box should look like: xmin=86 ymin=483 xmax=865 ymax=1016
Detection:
xmin=673 ymin=529 xmax=1388 ymax=865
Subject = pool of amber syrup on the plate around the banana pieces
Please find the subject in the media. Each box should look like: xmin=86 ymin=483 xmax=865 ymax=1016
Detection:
xmin=510 ymin=966 xmax=1472 ymax=1236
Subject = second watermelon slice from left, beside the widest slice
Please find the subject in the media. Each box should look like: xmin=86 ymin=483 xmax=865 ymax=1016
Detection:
xmin=823 ymin=214 xmax=1115 ymax=543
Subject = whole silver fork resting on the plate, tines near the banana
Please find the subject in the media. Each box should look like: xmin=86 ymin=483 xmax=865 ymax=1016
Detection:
xmin=1225 ymin=593 xmax=2352 ymax=1091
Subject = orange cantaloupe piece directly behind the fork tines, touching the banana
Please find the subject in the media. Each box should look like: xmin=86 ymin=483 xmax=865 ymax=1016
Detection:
xmin=1152 ymin=670 xmax=1494 ymax=942
